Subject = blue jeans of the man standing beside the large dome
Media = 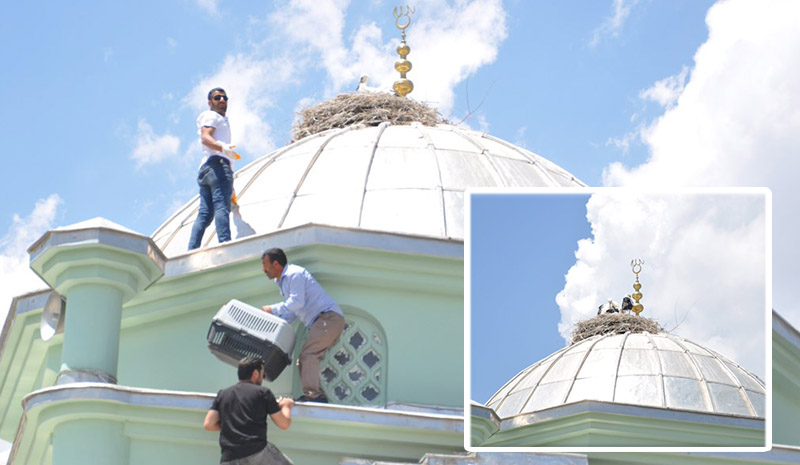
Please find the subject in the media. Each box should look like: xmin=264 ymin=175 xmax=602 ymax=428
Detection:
xmin=189 ymin=156 xmax=233 ymax=250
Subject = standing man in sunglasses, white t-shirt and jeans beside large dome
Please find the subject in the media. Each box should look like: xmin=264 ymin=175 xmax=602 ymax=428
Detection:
xmin=189 ymin=87 xmax=241 ymax=250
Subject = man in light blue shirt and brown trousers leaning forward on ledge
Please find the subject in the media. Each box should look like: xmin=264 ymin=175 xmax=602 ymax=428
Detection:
xmin=261 ymin=248 xmax=344 ymax=402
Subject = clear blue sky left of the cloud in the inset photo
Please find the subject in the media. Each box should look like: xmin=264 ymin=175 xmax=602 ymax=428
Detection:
xmin=468 ymin=194 xmax=592 ymax=403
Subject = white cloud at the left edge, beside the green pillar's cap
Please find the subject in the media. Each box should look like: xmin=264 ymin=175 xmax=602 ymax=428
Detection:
xmin=0 ymin=194 xmax=61 ymax=334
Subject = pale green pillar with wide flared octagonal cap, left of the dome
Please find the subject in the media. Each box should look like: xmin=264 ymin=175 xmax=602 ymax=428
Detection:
xmin=28 ymin=218 xmax=166 ymax=384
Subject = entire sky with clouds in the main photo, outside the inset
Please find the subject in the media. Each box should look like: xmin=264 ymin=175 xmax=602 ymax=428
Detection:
xmin=0 ymin=0 xmax=800 ymax=398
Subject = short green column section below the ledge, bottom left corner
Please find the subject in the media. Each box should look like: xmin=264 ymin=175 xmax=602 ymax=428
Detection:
xmin=53 ymin=420 xmax=130 ymax=465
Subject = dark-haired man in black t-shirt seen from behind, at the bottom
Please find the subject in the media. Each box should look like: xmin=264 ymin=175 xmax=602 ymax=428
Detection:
xmin=203 ymin=357 xmax=294 ymax=465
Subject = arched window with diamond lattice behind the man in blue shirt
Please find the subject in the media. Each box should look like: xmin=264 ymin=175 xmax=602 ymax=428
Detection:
xmin=297 ymin=307 xmax=387 ymax=405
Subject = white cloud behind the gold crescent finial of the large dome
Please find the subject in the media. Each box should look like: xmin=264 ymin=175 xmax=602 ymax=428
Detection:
xmin=271 ymin=0 xmax=507 ymax=115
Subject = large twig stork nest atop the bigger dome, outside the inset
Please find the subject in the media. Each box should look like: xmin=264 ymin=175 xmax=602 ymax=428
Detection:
xmin=292 ymin=92 xmax=447 ymax=140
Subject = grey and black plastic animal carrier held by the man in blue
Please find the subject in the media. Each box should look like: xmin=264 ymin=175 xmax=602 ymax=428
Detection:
xmin=208 ymin=299 xmax=295 ymax=381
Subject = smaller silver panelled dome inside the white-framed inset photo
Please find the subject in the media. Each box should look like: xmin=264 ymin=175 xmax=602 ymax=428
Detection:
xmin=486 ymin=332 xmax=766 ymax=419
